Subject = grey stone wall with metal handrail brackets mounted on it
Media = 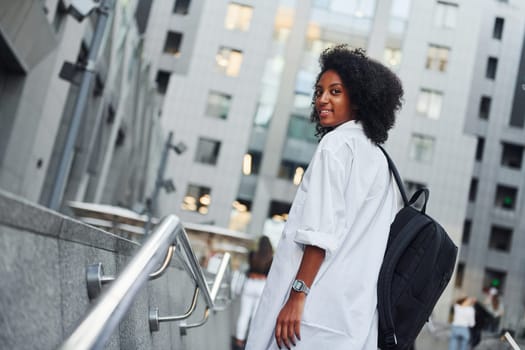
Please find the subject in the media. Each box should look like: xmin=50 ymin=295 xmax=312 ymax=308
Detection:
xmin=0 ymin=191 xmax=236 ymax=350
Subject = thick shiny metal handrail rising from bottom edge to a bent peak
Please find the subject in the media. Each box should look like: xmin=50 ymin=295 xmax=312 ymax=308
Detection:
xmin=59 ymin=215 xmax=223 ymax=350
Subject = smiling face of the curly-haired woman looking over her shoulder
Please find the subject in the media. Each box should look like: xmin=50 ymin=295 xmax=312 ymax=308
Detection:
xmin=315 ymin=70 xmax=354 ymax=127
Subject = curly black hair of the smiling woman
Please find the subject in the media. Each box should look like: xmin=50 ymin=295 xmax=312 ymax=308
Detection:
xmin=310 ymin=44 xmax=403 ymax=144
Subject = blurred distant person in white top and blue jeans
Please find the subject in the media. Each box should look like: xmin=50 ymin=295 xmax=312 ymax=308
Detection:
xmin=448 ymin=297 xmax=476 ymax=350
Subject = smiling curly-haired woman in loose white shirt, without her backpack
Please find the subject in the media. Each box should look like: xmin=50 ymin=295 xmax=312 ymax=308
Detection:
xmin=246 ymin=45 xmax=403 ymax=350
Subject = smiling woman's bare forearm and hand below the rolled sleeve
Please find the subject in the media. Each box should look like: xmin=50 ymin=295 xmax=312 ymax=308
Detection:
xmin=275 ymin=245 xmax=325 ymax=349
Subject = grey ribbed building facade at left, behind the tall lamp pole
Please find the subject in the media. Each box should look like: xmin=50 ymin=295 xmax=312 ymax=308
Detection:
xmin=0 ymin=0 xmax=157 ymax=212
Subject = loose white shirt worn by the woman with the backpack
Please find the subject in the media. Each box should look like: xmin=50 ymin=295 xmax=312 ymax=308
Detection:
xmin=246 ymin=121 xmax=398 ymax=350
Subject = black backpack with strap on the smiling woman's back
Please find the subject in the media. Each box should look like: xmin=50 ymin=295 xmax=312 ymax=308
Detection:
xmin=377 ymin=147 xmax=458 ymax=350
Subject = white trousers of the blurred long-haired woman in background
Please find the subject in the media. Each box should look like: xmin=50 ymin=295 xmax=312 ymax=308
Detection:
xmin=235 ymin=278 xmax=266 ymax=340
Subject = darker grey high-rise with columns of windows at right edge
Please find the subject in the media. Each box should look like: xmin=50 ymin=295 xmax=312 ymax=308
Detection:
xmin=455 ymin=1 xmax=525 ymax=333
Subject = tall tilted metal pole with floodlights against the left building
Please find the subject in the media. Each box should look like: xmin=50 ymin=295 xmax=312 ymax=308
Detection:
xmin=49 ymin=0 xmax=113 ymax=210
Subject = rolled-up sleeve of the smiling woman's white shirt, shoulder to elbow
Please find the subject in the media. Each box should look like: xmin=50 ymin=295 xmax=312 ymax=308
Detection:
xmin=294 ymin=149 xmax=351 ymax=259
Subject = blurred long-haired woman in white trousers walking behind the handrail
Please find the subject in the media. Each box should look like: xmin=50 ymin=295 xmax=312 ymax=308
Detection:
xmin=233 ymin=236 xmax=273 ymax=350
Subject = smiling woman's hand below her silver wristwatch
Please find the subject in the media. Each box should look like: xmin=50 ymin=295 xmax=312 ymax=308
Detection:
xmin=275 ymin=291 xmax=306 ymax=349
